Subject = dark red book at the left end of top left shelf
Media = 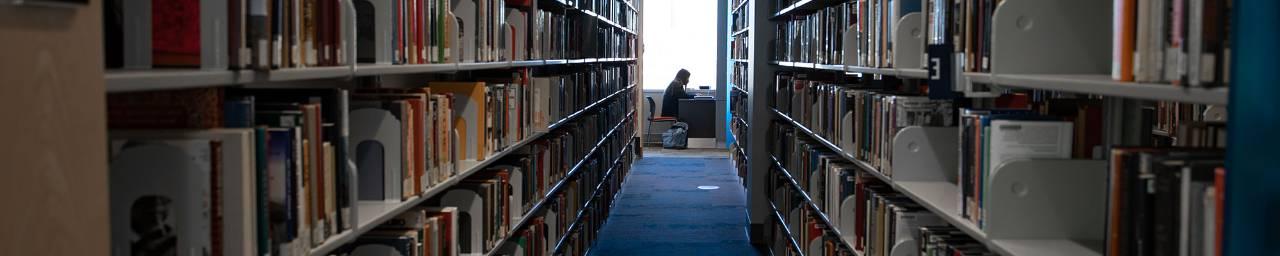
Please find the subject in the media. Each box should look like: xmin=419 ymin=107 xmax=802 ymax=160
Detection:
xmin=151 ymin=0 xmax=200 ymax=67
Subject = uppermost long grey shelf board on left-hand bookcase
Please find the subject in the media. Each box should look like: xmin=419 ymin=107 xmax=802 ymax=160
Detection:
xmin=104 ymin=58 xmax=636 ymax=92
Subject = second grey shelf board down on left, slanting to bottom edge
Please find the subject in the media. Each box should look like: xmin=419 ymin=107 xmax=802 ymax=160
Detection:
xmin=310 ymin=86 xmax=635 ymax=256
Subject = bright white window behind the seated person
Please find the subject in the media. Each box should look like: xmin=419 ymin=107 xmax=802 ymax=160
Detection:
xmin=641 ymin=0 xmax=717 ymax=90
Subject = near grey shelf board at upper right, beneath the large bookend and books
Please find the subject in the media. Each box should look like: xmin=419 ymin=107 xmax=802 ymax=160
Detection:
xmin=965 ymin=73 xmax=1228 ymax=105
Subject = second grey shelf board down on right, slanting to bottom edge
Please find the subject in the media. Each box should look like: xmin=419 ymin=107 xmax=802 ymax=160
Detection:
xmin=773 ymin=109 xmax=1102 ymax=256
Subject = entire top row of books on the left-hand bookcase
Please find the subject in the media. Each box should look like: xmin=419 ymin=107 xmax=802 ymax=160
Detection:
xmin=104 ymin=0 xmax=635 ymax=70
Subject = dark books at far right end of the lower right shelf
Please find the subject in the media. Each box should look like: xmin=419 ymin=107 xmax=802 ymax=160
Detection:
xmin=1106 ymin=147 xmax=1226 ymax=256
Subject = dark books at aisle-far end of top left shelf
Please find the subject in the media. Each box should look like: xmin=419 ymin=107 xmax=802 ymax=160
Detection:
xmin=532 ymin=10 xmax=637 ymax=59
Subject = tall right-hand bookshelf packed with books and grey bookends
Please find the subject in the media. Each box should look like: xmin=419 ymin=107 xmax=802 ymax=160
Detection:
xmin=726 ymin=0 xmax=1254 ymax=256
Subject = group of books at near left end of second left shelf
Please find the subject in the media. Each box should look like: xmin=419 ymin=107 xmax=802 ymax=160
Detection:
xmin=108 ymin=88 xmax=358 ymax=255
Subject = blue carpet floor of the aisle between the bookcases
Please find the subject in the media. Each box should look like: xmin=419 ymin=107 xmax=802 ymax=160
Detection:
xmin=590 ymin=156 xmax=759 ymax=256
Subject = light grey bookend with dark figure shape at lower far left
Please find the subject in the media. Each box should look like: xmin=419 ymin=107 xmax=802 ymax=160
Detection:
xmin=108 ymin=138 xmax=215 ymax=255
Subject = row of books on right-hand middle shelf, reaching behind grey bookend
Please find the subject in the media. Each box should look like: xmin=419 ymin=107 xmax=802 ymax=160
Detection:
xmin=772 ymin=73 xmax=955 ymax=177
